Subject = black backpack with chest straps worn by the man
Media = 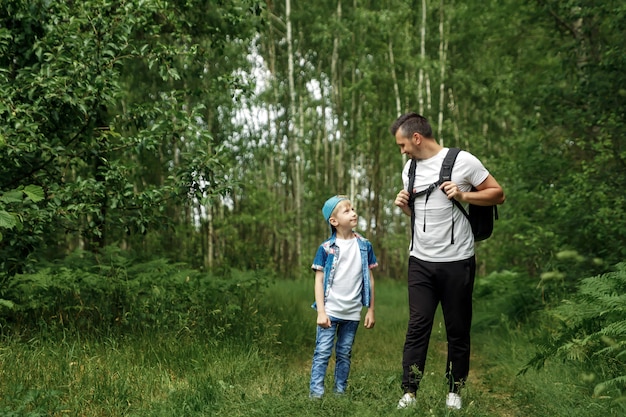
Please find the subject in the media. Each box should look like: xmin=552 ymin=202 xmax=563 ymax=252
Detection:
xmin=409 ymin=148 xmax=498 ymax=245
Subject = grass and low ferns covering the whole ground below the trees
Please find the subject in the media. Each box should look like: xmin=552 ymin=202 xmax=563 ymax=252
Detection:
xmin=0 ymin=251 xmax=625 ymax=417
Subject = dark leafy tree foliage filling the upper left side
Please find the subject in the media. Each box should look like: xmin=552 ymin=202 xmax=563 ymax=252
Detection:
xmin=0 ymin=0 xmax=260 ymax=274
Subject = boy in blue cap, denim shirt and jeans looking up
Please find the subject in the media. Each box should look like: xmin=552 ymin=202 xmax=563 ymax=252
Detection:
xmin=309 ymin=195 xmax=378 ymax=398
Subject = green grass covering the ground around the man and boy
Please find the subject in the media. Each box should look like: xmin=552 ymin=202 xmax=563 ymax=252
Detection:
xmin=0 ymin=279 xmax=624 ymax=417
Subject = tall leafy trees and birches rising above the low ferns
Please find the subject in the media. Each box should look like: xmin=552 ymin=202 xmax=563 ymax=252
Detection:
xmin=0 ymin=0 xmax=626 ymax=277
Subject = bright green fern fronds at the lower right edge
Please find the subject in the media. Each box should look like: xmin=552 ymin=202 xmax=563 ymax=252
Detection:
xmin=525 ymin=263 xmax=626 ymax=402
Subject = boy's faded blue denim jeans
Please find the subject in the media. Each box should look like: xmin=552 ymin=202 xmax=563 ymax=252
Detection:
xmin=309 ymin=317 xmax=360 ymax=397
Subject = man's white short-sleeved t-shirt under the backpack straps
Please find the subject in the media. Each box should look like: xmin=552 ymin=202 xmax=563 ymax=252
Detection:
xmin=402 ymin=148 xmax=489 ymax=262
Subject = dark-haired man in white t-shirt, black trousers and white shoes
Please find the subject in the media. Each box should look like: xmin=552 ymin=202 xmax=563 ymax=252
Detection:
xmin=391 ymin=113 xmax=504 ymax=409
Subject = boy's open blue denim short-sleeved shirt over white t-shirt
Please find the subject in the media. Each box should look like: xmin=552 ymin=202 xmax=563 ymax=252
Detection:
xmin=311 ymin=232 xmax=378 ymax=308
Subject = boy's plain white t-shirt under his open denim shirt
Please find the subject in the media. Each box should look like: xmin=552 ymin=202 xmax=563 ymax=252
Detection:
xmin=324 ymin=238 xmax=363 ymax=321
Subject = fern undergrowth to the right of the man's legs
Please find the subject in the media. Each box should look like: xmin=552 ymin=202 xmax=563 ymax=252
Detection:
xmin=474 ymin=263 xmax=626 ymax=411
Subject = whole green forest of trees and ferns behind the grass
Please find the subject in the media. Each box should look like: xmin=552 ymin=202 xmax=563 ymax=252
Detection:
xmin=0 ymin=0 xmax=626 ymax=416
